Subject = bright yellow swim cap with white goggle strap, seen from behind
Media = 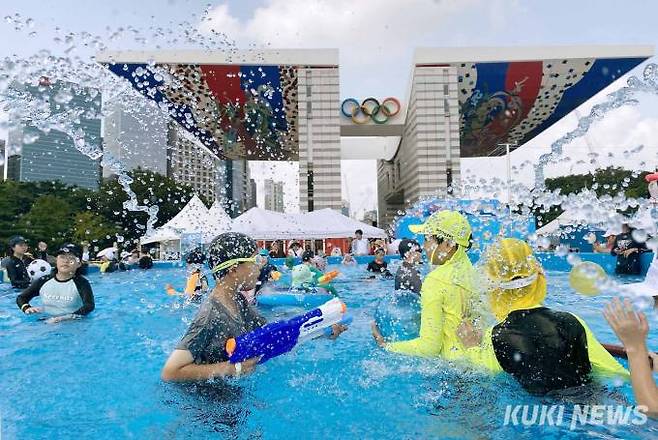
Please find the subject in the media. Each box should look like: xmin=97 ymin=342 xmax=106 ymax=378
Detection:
xmin=481 ymin=238 xmax=546 ymax=320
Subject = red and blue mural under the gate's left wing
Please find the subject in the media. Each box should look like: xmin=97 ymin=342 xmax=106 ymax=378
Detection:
xmin=107 ymin=63 xmax=299 ymax=161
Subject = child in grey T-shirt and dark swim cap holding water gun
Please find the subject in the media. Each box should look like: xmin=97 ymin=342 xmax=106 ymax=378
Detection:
xmin=162 ymin=232 xmax=346 ymax=382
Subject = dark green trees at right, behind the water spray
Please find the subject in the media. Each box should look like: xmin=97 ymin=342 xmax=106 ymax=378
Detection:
xmin=535 ymin=167 xmax=649 ymax=227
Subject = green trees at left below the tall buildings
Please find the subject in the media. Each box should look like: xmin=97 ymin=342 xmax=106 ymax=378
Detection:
xmin=0 ymin=169 xmax=202 ymax=249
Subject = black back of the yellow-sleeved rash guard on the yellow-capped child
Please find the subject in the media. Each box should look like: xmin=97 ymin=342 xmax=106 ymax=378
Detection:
xmin=491 ymin=307 xmax=592 ymax=394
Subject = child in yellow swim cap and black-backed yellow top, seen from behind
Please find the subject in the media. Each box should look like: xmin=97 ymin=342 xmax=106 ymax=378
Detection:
xmin=459 ymin=238 xmax=628 ymax=394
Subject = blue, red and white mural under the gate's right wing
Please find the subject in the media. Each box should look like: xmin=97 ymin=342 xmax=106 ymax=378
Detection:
xmin=456 ymin=58 xmax=645 ymax=157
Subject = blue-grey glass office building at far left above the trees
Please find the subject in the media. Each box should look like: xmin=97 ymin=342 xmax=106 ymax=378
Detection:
xmin=5 ymin=82 xmax=102 ymax=189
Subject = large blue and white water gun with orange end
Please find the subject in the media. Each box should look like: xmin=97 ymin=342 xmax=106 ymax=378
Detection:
xmin=226 ymin=298 xmax=351 ymax=364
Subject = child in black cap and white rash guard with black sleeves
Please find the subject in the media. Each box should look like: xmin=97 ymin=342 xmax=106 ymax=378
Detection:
xmin=16 ymin=244 xmax=95 ymax=323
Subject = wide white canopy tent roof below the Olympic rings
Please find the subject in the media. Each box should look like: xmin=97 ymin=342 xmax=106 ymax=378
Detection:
xmin=231 ymin=208 xmax=386 ymax=240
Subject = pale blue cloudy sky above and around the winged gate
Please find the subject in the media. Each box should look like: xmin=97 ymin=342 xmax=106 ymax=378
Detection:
xmin=0 ymin=0 xmax=658 ymax=216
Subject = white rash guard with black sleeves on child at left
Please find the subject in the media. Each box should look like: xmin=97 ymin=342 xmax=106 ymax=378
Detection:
xmin=16 ymin=274 xmax=96 ymax=316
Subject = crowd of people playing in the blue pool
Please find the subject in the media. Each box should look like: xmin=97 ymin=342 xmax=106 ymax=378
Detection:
xmin=3 ymin=211 xmax=658 ymax=420
